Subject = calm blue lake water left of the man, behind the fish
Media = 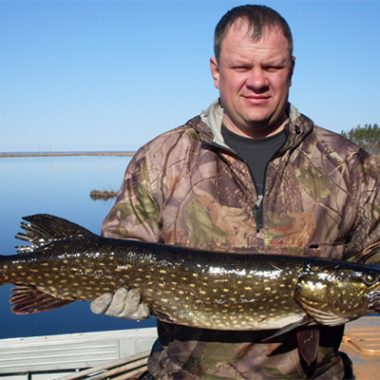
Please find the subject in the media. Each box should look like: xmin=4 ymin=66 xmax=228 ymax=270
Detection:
xmin=0 ymin=156 xmax=156 ymax=338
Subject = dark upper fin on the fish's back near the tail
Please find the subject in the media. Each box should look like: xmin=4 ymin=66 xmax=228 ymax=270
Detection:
xmin=16 ymin=214 xmax=97 ymax=254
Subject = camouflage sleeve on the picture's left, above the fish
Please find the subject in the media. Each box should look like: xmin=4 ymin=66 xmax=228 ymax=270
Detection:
xmin=102 ymin=147 xmax=161 ymax=242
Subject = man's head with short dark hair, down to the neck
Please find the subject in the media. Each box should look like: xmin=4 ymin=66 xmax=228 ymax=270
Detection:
xmin=211 ymin=5 xmax=294 ymax=137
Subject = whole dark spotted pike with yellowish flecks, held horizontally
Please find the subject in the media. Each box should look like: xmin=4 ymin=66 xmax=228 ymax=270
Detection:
xmin=0 ymin=214 xmax=380 ymax=331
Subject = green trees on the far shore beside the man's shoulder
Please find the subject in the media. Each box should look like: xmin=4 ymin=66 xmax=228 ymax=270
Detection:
xmin=342 ymin=124 xmax=380 ymax=155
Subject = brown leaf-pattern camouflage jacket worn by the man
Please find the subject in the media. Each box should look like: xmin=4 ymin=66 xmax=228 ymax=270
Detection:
xmin=102 ymin=101 xmax=380 ymax=380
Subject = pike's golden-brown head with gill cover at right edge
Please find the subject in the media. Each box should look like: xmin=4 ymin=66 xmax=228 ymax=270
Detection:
xmin=295 ymin=264 xmax=380 ymax=326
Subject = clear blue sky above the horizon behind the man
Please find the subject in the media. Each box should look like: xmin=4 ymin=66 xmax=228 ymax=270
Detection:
xmin=0 ymin=0 xmax=380 ymax=152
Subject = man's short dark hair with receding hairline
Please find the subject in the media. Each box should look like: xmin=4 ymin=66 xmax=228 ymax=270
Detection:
xmin=214 ymin=5 xmax=293 ymax=60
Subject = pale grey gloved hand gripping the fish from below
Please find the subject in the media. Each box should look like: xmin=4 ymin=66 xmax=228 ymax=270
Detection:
xmin=90 ymin=288 xmax=150 ymax=321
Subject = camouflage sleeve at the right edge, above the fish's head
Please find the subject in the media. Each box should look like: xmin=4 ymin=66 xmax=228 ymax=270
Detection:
xmin=346 ymin=150 xmax=380 ymax=264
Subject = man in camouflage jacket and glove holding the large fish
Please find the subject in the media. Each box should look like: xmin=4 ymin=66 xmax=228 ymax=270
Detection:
xmin=92 ymin=5 xmax=380 ymax=380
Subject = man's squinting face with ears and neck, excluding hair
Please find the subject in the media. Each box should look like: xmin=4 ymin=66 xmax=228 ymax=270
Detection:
xmin=211 ymin=21 xmax=295 ymax=138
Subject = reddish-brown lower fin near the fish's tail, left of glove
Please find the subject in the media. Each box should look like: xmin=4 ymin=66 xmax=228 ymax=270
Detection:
xmin=10 ymin=285 xmax=75 ymax=314
